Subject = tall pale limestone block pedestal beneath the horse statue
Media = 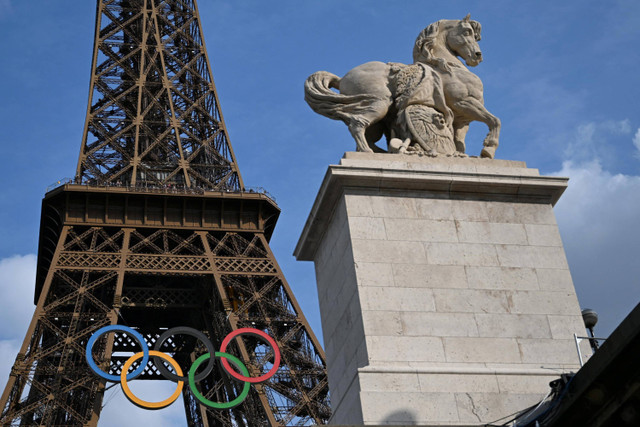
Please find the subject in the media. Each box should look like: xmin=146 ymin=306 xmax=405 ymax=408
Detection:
xmin=295 ymin=153 xmax=588 ymax=425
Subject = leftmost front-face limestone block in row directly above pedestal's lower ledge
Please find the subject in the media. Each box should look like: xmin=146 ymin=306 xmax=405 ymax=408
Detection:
xmin=366 ymin=336 xmax=445 ymax=365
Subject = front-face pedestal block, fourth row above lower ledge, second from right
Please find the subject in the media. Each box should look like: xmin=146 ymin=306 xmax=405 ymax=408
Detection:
xmin=465 ymin=266 xmax=539 ymax=291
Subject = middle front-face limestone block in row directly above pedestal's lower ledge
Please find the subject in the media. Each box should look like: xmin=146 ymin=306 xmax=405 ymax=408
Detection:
xmin=442 ymin=337 xmax=521 ymax=363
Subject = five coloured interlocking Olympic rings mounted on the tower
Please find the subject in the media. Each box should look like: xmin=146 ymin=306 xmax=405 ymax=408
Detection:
xmin=85 ymin=325 xmax=280 ymax=409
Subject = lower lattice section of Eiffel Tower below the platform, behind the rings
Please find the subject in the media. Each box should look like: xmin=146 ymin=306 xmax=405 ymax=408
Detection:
xmin=0 ymin=225 xmax=330 ymax=426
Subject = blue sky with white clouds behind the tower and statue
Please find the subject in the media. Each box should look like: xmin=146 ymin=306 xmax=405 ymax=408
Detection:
xmin=0 ymin=0 xmax=640 ymax=425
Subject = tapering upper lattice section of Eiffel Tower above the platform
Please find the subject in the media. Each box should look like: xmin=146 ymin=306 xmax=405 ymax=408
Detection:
xmin=76 ymin=0 xmax=242 ymax=190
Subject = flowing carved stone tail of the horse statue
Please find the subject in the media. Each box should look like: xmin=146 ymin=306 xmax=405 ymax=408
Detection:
xmin=304 ymin=71 xmax=380 ymax=125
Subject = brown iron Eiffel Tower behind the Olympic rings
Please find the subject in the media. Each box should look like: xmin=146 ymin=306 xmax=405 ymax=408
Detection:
xmin=0 ymin=0 xmax=331 ymax=427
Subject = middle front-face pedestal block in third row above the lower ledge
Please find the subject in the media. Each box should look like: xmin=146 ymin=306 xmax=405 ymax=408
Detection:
xmin=433 ymin=289 xmax=510 ymax=313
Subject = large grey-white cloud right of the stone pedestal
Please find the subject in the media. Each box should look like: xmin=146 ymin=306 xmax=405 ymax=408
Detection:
xmin=553 ymin=160 xmax=640 ymax=336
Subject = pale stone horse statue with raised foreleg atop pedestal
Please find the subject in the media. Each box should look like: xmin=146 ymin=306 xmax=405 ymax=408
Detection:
xmin=305 ymin=15 xmax=500 ymax=158
